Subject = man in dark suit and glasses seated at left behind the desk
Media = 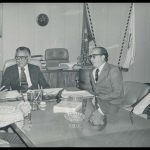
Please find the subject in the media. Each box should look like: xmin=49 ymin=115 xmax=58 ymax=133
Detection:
xmin=2 ymin=47 xmax=49 ymax=92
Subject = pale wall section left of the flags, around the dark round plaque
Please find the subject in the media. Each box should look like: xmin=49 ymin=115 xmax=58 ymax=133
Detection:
xmin=3 ymin=3 xmax=82 ymax=61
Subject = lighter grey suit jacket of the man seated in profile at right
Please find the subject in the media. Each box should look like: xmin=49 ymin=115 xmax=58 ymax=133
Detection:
xmin=90 ymin=63 xmax=124 ymax=113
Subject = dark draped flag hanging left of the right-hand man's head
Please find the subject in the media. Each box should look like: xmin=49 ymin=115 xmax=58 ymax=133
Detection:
xmin=81 ymin=3 xmax=95 ymax=65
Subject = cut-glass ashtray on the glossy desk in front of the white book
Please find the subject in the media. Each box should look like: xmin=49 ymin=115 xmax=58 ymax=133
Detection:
xmin=64 ymin=112 xmax=85 ymax=122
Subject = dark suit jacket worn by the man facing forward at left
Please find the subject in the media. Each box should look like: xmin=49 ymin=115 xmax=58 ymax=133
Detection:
xmin=2 ymin=64 xmax=49 ymax=91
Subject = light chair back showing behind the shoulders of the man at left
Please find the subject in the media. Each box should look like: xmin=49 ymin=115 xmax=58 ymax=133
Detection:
xmin=3 ymin=58 xmax=42 ymax=73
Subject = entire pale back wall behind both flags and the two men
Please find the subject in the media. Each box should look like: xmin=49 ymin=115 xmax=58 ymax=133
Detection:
xmin=0 ymin=3 xmax=150 ymax=82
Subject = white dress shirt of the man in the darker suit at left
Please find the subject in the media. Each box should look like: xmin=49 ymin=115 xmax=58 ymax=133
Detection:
xmin=18 ymin=64 xmax=32 ymax=88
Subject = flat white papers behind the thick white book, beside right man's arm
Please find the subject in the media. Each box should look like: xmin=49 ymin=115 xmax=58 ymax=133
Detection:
xmin=61 ymin=90 xmax=94 ymax=98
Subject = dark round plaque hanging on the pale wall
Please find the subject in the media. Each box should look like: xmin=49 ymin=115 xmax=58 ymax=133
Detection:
xmin=37 ymin=14 xmax=49 ymax=26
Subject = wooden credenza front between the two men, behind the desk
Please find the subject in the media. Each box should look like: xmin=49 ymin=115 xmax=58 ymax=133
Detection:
xmin=42 ymin=69 xmax=78 ymax=88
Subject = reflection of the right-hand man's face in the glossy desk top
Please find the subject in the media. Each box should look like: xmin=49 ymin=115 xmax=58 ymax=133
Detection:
xmin=90 ymin=110 xmax=104 ymax=125
